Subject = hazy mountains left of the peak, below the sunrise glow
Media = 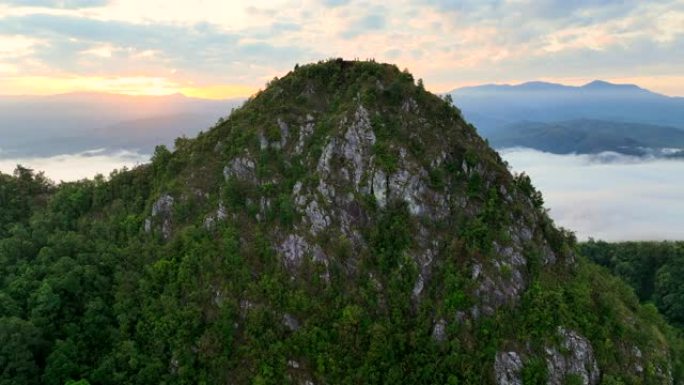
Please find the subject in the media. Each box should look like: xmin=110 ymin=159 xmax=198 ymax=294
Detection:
xmin=0 ymin=93 xmax=242 ymax=158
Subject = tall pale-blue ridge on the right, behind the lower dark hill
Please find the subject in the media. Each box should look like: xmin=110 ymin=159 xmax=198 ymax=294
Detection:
xmin=451 ymin=80 xmax=684 ymax=135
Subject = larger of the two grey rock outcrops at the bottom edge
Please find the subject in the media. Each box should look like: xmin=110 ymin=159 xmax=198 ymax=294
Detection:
xmin=545 ymin=328 xmax=601 ymax=385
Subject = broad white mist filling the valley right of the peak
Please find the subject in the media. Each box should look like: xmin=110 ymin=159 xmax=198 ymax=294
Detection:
xmin=500 ymin=149 xmax=684 ymax=241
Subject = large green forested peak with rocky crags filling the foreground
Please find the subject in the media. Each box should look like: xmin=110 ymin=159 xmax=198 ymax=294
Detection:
xmin=0 ymin=60 xmax=680 ymax=385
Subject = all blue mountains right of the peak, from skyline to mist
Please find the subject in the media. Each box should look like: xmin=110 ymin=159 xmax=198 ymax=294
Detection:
xmin=451 ymin=80 xmax=684 ymax=155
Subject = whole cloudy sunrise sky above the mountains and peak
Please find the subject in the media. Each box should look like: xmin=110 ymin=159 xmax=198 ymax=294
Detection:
xmin=0 ymin=0 xmax=684 ymax=99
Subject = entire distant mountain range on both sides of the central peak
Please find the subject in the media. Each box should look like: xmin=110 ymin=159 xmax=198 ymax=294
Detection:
xmin=0 ymin=80 xmax=684 ymax=158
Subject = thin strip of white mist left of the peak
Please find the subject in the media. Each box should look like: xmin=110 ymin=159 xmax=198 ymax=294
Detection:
xmin=0 ymin=149 xmax=150 ymax=182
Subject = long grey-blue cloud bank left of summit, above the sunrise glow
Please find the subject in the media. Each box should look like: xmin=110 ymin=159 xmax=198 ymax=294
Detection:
xmin=0 ymin=14 xmax=314 ymax=76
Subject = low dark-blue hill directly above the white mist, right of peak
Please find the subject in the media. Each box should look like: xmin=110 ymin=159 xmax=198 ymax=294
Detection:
xmin=489 ymin=119 xmax=684 ymax=156
